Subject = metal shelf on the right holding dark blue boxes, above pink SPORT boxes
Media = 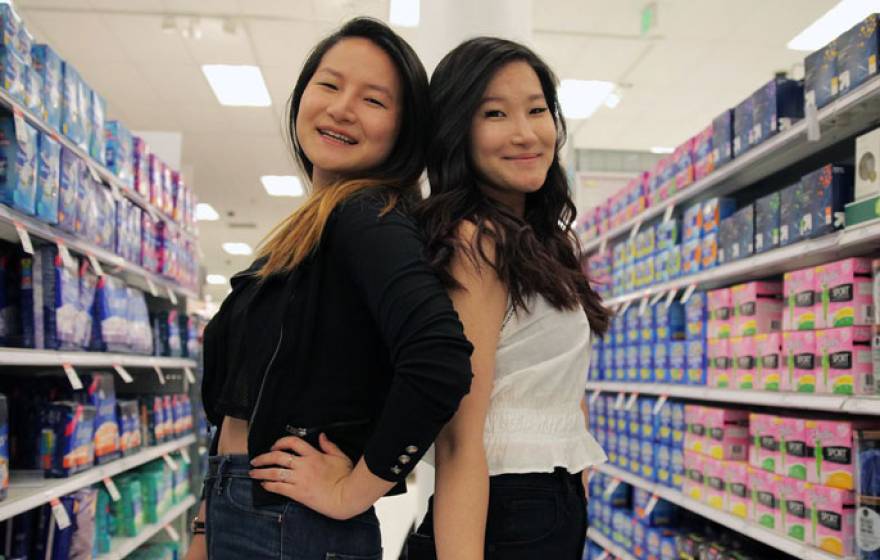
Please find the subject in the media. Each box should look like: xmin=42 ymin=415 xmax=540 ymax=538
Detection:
xmin=605 ymin=222 xmax=880 ymax=307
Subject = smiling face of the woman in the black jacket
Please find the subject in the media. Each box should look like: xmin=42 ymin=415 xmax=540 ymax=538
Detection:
xmin=296 ymin=37 xmax=402 ymax=187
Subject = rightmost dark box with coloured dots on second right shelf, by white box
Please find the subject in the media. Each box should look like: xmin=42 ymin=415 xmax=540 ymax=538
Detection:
xmin=800 ymin=164 xmax=853 ymax=238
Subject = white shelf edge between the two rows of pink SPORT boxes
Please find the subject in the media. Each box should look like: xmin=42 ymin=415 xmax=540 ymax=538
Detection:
xmin=587 ymin=381 xmax=880 ymax=416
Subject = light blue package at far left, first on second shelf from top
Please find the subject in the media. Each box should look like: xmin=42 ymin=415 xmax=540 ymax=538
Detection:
xmin=0 ymin=116 xmax=39 ymax=215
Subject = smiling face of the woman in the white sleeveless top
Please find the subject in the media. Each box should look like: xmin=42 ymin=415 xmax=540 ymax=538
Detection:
xmin=471 ymin=61 xmax=556 ymax=214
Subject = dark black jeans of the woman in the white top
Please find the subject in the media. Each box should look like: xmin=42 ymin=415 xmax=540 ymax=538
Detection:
xmin=405 ymin=468 xmax=587 ymax=560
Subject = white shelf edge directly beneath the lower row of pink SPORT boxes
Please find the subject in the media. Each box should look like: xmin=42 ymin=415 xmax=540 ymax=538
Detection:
xmin=596 ymin=464 xmax=846 ymax=560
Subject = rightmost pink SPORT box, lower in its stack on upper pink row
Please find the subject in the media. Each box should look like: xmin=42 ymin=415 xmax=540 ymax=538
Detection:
xmin=816 ymin=327 xmax=876 ymax=395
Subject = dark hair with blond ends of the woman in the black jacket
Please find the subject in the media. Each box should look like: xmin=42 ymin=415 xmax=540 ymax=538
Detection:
xmin=259 ymin=17 xmax=431 ymax=278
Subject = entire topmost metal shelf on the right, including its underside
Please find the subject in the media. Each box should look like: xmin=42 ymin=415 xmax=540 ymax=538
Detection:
xmin=581 ymin=72 xmax=880 ymax=253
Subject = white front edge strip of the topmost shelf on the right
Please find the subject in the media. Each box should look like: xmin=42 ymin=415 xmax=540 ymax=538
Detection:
xmin=581 ymin=73 xmax=880 ymax=253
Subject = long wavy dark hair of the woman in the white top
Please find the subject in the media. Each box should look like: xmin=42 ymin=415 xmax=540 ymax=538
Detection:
xmin=417 ymin=37 xmax=609 ymax=335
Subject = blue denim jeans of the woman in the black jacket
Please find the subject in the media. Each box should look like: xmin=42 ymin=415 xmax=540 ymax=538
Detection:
xmin=205 ymin=455 xmax=382 ymax=560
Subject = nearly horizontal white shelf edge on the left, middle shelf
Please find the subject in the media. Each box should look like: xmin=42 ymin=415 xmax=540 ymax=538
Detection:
xmin=0 ymin=347 xmax=197 ymax=369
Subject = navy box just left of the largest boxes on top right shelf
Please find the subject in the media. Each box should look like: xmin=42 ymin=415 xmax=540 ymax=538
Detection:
xmin=751 ymin=78 xmax=804 ymax=146
